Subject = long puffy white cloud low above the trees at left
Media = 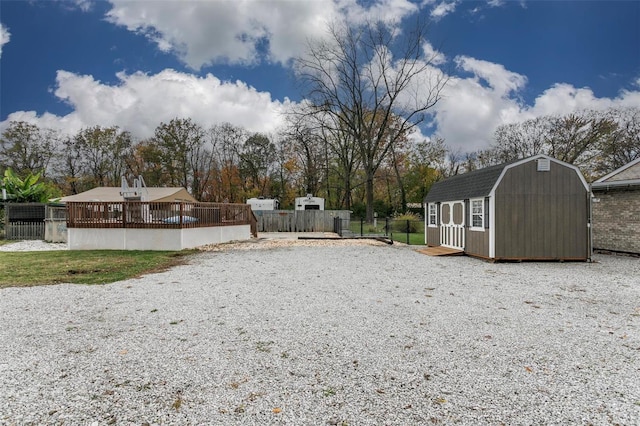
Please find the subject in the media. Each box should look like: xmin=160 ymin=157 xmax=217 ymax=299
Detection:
xmin=0 ymin=70 xmax=289 ymax=138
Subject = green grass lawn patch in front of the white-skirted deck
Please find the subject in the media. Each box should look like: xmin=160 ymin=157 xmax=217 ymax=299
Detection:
xmin=0 ymin=250 xmax=194 ymax=288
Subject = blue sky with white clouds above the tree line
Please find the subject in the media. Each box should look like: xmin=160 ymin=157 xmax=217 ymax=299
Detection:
xmin=0 ymin=0 xmax=640 ymax=152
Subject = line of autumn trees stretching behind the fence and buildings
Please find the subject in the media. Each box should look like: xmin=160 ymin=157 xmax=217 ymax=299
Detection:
xmin=0 ymin=108 xmax=640 ymax=214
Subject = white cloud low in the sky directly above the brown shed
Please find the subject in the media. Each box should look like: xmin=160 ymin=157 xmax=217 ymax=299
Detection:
xmin=434 ymin=57 xmax=640 ymax=152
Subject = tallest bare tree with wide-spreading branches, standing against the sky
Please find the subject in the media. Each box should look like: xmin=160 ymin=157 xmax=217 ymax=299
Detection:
xmin=295 ymin=18 xmax=447 ymax=221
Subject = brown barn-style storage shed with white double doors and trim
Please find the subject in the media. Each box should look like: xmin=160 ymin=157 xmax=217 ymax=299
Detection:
xmin=424 ymin=155 xmax=591 ymax=260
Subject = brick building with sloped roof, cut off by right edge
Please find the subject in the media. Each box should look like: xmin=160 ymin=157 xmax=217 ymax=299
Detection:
xmin=591 ymin=158 xmax=640 ymax=254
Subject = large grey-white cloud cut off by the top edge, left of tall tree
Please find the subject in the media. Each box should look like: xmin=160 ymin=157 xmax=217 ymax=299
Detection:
xmin=107 ymin=0 xmax=418 ymax=70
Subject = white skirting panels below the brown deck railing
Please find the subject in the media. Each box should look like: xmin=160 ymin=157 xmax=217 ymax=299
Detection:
xmin=67 ymin=225 xmax=251 ymax=251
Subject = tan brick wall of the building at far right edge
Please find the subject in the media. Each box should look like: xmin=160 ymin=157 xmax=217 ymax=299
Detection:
xmin=592 ymin=189 xmax=640 ymax=253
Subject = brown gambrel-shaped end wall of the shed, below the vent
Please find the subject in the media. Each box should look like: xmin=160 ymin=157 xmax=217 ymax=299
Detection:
xmin=495 ymin=161 xmax=589 ymax=259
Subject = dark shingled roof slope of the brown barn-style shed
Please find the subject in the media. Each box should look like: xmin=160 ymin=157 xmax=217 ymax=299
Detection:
xmin=424 ymin=163 xmax=511 ymax=203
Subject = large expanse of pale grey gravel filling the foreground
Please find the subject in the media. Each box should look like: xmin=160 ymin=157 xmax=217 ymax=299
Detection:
xmin=0 ymin=241 xmax=640 ymax=425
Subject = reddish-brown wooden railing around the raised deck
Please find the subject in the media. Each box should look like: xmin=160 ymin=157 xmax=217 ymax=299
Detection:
xmin=67 ymin=201 xmax=255 ymax=235
